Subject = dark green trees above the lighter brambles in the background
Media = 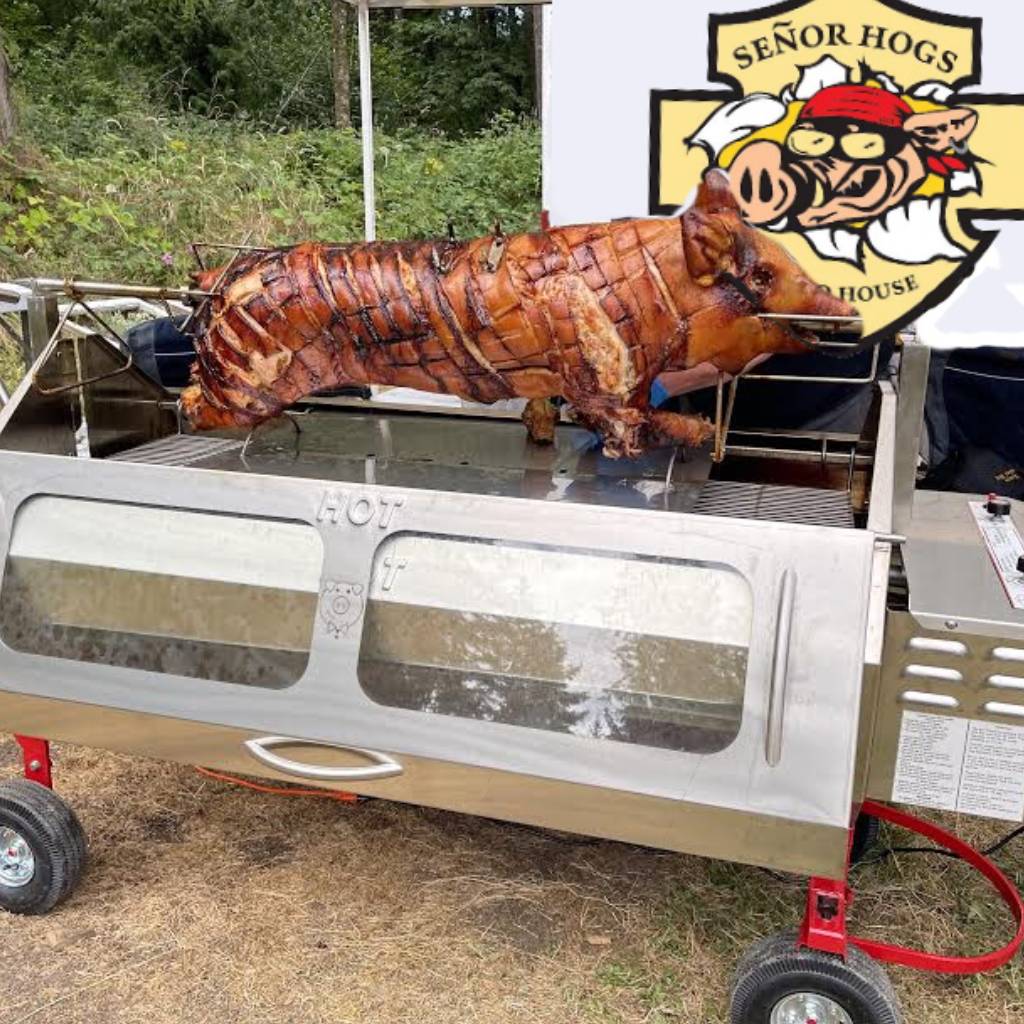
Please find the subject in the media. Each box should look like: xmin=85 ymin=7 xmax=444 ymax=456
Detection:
xmin=0 ymin=0 xmax=535 ymax=134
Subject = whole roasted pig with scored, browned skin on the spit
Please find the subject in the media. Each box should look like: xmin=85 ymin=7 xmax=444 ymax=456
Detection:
xmin=182 ymin=174 xmax=855 ymax=456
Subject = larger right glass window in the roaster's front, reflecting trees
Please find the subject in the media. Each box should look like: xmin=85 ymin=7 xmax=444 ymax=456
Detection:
xmin=359 ymin=534 xmax=753 ymax=753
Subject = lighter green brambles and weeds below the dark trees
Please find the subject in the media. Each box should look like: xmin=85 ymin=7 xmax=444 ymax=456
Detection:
xmin=0 ymin=115 xmax=540 ymax=283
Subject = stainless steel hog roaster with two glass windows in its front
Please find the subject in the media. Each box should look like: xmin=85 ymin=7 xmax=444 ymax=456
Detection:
xmin=0 ymin=280 xmax=1024 ymax=1020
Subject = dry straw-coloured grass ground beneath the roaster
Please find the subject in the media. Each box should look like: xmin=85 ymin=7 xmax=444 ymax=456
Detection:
xmin=0 ymin=740 xmax=1024 ymax=1024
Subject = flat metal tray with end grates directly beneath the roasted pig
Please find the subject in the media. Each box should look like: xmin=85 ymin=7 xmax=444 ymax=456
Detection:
xmin=103 ymin=411 xmax=854 ymax=528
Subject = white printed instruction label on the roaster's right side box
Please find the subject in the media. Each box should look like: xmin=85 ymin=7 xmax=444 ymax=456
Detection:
xmin=892 ymin=711 xmax=1024 ymax=821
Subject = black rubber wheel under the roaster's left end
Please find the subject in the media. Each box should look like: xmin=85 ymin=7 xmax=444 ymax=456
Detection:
xmin=0 ymin=778 xmax=86 ymax=913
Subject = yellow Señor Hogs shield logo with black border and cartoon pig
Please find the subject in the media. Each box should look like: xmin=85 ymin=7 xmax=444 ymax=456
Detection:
xmin=650 ymin=0 xmax=1024 ymax=338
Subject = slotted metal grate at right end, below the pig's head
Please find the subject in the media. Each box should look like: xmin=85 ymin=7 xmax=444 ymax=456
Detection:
xmin=693 ymin=480 xmax=854 ymax=528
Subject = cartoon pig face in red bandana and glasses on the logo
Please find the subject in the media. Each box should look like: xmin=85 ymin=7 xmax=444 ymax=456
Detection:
xmin=730 ymin=85 xmax=978 ymax=229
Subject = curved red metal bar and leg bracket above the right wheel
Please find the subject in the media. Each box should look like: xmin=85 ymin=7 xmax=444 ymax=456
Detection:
xmin=799 ymin=802 xmax=1024 ymax=974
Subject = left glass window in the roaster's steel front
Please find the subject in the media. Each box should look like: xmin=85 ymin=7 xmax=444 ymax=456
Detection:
xmin=0 ymin=496 xmax=324 ymax=687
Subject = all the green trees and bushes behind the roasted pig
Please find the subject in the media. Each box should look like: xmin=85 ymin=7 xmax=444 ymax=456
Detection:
xmin=0 ymin=0 xmax=540 ymax=296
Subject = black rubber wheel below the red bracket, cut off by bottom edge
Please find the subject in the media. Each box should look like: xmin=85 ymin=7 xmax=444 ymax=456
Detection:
xmin=730 ymin=932 xmax=903 ymax=1024
